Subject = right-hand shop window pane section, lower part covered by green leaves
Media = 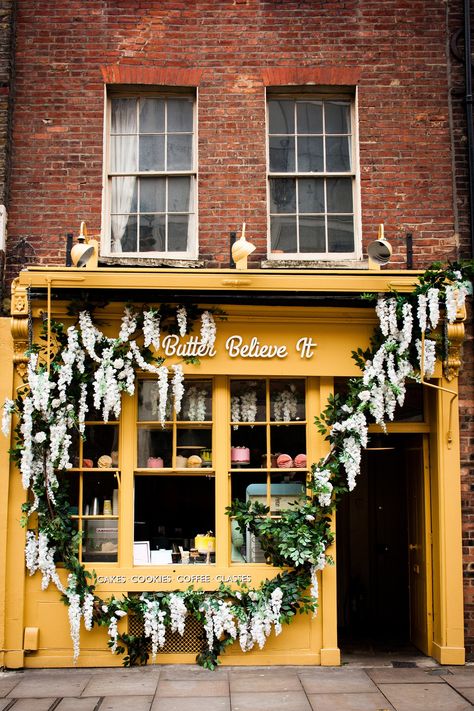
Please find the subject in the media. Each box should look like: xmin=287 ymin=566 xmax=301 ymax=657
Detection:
xmin=230 ymin=379 xmax=307 ymax=563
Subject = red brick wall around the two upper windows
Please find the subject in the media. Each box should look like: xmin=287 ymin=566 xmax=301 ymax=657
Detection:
xmin=2 ymin=0 xmax=474 ymax=652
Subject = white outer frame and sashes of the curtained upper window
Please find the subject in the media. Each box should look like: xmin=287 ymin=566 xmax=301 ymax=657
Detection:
xmin=101 ymin=87 xmax=199 ymax=262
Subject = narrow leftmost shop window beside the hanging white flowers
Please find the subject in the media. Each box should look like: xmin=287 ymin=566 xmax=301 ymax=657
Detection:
xmin=62 ymin=420 xmax=120 ymax=563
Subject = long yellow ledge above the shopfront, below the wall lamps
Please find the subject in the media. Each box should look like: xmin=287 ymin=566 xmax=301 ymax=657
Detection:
xmin=12 ymin=267 xmax=421 ymax=312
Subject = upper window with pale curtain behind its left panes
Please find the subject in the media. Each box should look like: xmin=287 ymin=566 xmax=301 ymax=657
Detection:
xmin=106 ymin=95 xmax=197 ymax=259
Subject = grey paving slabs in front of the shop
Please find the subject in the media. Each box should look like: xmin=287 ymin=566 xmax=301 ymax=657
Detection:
xmin=0 ymin=657 xmax=474 ymax=711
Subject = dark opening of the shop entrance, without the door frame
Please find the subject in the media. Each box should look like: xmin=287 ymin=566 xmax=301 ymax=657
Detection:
xmin=336 ymin=435 xmax=422 ymax=652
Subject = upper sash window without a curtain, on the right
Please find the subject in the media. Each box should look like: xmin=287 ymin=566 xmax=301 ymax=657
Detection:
xmin=268 ymin=95 xmax=358 ymax=260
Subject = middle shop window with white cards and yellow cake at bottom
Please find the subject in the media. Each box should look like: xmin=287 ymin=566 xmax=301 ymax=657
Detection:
xmin=134 ymin=380 xmax=215 ymax=565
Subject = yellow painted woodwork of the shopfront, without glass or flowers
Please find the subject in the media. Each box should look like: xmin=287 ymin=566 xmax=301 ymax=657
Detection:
xmin=0 ymin=268 xmax=464 ymax=668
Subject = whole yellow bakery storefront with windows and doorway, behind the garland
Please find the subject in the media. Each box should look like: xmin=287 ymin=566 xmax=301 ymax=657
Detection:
xmin=0 ymin=268 xmax=464 ymax=668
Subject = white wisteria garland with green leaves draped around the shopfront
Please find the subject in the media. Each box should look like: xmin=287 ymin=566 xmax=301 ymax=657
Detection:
xmin=2 ymin=264 xmax=473 ymax=668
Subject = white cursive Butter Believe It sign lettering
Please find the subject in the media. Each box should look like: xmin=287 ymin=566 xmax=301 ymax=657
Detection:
xmin=162 ymin=334 xmax=318 ymax=359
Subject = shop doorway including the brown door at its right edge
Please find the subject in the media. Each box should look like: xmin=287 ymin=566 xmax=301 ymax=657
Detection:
xmin=336 ymin=434 xmax=432 ymax=654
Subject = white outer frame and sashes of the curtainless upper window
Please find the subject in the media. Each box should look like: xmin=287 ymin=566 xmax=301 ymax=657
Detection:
xmin=265 ymin=87 xmax=362 ymax=263
